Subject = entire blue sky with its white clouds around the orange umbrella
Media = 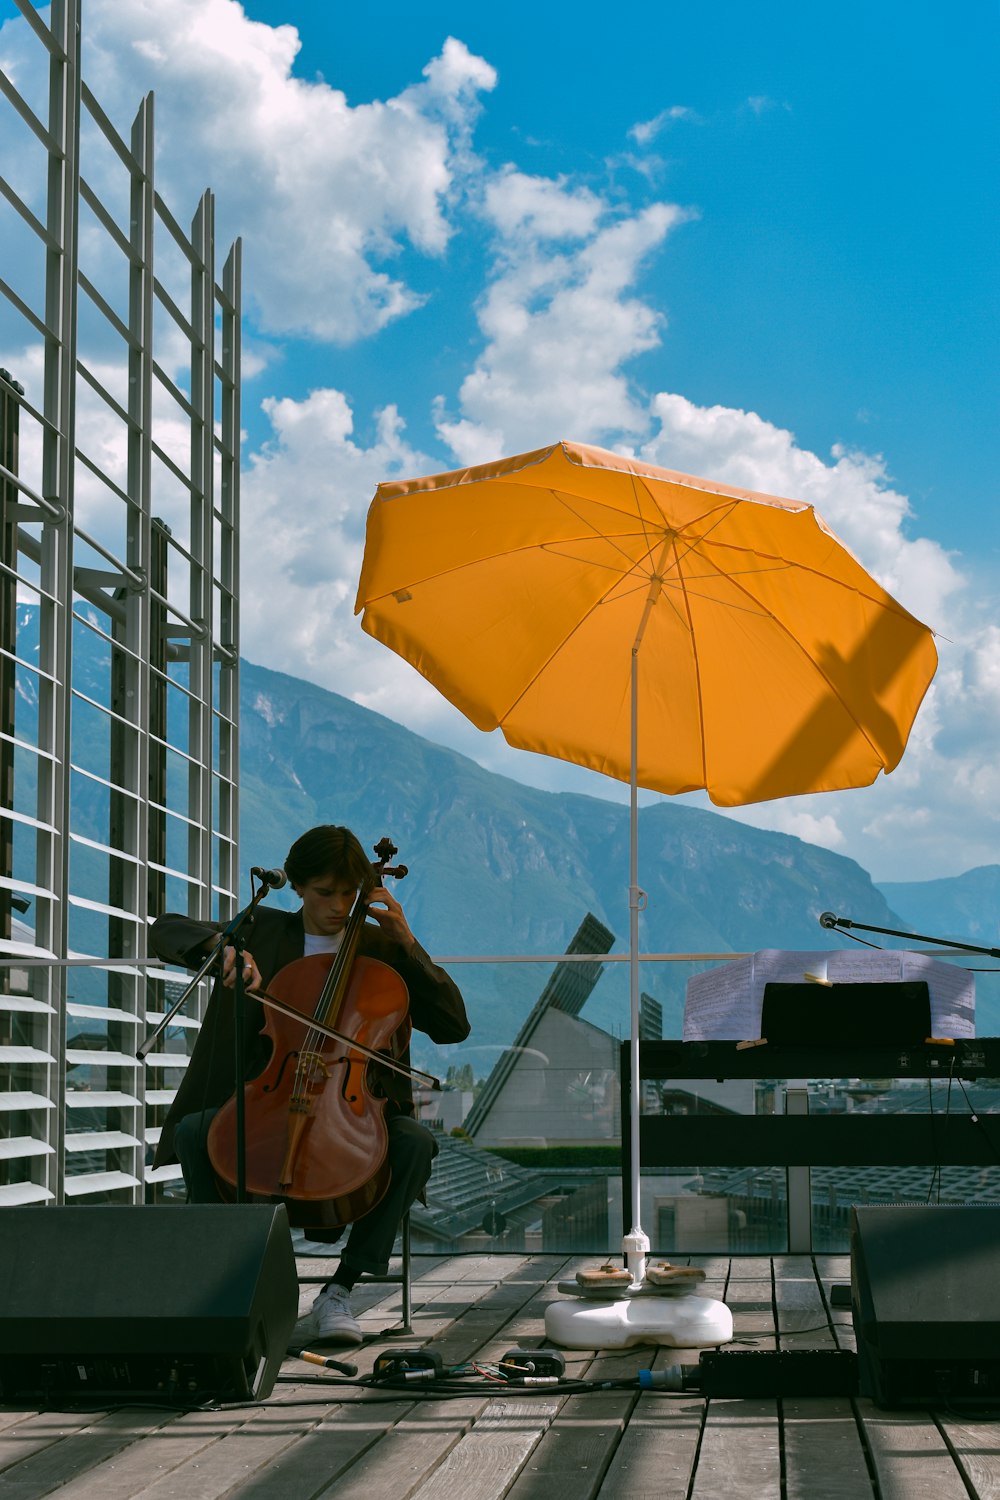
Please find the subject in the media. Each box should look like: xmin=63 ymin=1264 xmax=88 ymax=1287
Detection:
xmin=0 ymin=0 xmax=1000 ymax=879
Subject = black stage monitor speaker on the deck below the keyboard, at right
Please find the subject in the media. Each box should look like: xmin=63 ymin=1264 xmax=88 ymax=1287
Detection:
xmin=850 ymin=1203 xmax=1000 ymax=1407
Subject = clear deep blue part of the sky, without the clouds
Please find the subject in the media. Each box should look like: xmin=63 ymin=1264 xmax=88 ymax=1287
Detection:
xmin=239 ymin=0 xmax=1000 ymax=549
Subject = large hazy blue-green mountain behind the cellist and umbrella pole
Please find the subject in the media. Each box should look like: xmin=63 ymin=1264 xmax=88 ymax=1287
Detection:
xmin=240 ymin=662 xmax=983 ymax=1071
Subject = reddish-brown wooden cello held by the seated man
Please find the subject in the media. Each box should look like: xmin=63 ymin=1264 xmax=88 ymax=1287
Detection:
xmin=208 ymin=839 xmax=412 ymax=1230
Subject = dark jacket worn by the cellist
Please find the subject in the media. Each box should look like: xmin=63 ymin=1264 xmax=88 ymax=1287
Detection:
xmin=150 ymin=908 xmax=469 ymax=1167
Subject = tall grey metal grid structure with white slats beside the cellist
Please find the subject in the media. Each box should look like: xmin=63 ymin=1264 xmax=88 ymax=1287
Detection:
xmin=0 ymin=0 xmax=240 ymax=1205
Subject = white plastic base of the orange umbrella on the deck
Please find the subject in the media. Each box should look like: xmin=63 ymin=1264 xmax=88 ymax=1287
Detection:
xmin=546 ymin=1296 xmax=733 ymax=1349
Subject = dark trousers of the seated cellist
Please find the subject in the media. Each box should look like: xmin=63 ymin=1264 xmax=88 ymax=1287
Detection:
xmin=174 ymin=1110 xmax=438 ymax=1277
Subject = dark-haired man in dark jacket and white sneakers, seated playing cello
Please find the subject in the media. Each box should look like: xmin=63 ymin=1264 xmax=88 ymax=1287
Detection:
xmin=150 ymin=824 xmax=469 ymax=1344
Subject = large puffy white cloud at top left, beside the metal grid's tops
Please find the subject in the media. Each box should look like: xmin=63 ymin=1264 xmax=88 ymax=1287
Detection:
xmin=3 ymin=0 xmax=496 ymax=344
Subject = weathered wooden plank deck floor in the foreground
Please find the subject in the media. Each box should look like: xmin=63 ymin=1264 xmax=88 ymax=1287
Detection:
xmin=0 ymin=1256 xmax=1000 ymax=1500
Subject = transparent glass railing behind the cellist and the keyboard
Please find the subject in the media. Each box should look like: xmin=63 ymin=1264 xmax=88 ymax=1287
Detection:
xmin=0 ymin=954 xmax=1000 ymax=1259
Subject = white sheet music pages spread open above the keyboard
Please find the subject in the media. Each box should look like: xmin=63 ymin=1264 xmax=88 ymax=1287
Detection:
xmin=684 ymin=948 xmax=976 ymax=1041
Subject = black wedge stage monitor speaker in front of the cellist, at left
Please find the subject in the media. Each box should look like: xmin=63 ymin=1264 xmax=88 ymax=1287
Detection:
xmin=0 ymin=1203 xmax=298 ymax=1401
